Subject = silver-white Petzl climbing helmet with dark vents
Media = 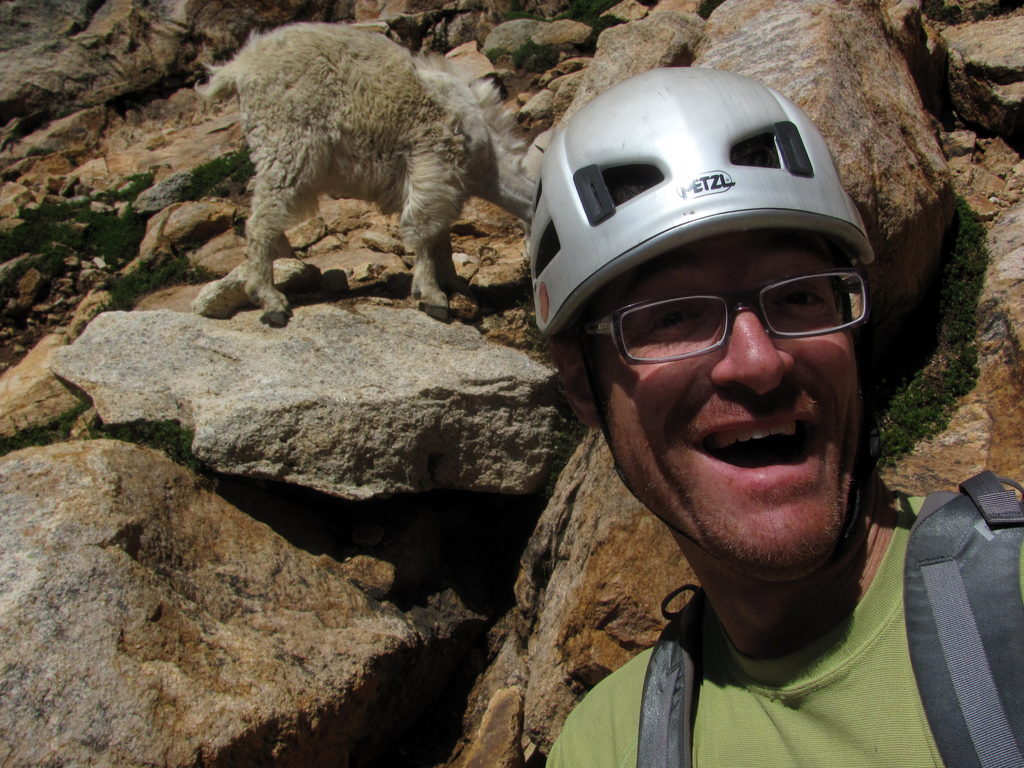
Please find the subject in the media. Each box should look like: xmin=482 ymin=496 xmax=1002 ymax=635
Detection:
xmin=529 ymin=68 xmax=873 ymax=335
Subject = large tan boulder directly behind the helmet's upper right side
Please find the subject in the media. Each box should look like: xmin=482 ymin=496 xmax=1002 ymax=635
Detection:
xmin=694 ymin=0 xmax=952 ymax=346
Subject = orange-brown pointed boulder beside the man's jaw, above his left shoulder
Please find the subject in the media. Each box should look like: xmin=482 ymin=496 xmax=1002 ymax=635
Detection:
xmin=511 ymin=431 xmax=696 ymax=752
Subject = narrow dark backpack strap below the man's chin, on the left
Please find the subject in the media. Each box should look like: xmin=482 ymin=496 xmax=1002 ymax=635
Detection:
xmin=637 ymin=591 xmax=703 ymax=768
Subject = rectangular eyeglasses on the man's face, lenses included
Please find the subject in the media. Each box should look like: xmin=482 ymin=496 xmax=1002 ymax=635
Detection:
xmin=583 ymin=269 xmax=868 ymax=362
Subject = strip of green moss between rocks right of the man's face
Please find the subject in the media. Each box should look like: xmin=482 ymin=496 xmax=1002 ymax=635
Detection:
xmin=880 ymin=199 xmax=988 ymax=464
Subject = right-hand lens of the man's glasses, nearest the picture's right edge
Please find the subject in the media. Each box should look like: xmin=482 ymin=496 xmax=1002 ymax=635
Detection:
xmin=761 ymin=272 xmax=866 ymax=334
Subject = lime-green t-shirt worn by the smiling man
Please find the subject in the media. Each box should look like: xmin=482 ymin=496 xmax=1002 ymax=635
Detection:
xmin=547 ymin=499 xmax=1024 ymax=768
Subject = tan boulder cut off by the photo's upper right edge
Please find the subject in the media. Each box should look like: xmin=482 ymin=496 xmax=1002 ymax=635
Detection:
xmin=942 ymin=9 xmax=1024 ymax=138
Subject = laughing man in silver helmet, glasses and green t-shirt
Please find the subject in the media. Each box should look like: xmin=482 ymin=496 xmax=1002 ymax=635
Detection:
xmin=530 ymin=69 xmax=1024 ymax=768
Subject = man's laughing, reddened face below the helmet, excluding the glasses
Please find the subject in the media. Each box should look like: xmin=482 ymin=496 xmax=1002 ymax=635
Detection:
xmin=592 ymin=232 xmax=860 ymax=581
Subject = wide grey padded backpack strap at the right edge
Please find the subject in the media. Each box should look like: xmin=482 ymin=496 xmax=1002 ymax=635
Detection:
xmin=903 ymin=472 xmax=1024 ymax=768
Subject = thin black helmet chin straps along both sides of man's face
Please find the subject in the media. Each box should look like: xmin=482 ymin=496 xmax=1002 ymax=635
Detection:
xmin=577 ymin=323 xmax=882 ymax=559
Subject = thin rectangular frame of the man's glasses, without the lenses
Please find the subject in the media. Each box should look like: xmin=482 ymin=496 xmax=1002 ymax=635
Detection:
xmin=581 ymin=267 xmax=871 ymax=365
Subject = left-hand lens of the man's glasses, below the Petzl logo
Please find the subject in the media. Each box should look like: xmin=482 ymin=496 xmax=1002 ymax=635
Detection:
xmin=618 ymin=296 xmax=726 ymax=360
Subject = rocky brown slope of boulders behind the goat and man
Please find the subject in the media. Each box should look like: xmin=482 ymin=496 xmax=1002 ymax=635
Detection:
xmin=0 ymin=0 xmax=1024 ymax=768
